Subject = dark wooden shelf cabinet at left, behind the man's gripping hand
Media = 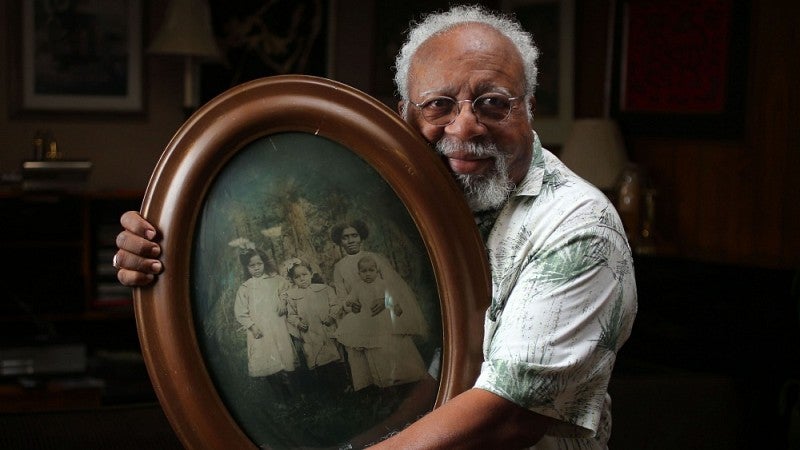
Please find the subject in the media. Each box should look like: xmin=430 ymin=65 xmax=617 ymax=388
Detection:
xmin=0 ymin=192 xmax=153 ymax=411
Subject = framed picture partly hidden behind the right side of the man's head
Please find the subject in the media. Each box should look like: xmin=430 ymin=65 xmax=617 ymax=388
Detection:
xmin=502 ymin=0 xmax=575 ymax=147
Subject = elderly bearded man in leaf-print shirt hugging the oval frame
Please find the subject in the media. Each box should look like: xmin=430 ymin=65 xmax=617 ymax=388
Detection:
xmin=115 ymin=6 xmax=636 ymax=449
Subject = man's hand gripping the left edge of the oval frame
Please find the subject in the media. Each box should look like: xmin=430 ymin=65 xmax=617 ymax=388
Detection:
xmin=113 ymin=211 xmax=164 ymax=286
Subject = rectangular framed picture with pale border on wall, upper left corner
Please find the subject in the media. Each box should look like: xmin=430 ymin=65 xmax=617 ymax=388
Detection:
xmin=11 ymin=0 xmax=143 ymax=113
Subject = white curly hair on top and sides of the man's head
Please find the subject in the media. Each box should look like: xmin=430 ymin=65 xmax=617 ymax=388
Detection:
xmin=394 ymin=5 xmax=539 ymax=105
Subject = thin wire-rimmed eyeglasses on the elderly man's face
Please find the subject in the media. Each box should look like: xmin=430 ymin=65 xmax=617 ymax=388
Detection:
xmin=411 ymin=93 xmax=520 ymax=127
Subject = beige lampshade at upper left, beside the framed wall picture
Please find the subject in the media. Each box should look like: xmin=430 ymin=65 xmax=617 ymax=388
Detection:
xmin=147 ymin=0 xmax=222 ymax=60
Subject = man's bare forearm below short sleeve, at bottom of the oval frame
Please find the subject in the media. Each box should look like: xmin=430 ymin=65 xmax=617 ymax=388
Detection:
xmin=371 ymin=388 xmax=554 ymax=449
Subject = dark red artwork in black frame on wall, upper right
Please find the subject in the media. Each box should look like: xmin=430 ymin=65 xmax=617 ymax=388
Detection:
xmin=610 ymin=0 xmax=749 ymax=138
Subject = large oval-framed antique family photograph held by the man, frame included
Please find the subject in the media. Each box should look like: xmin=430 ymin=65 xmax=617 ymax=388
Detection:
xmin=134 ymin=75 xmax=491 ymax=449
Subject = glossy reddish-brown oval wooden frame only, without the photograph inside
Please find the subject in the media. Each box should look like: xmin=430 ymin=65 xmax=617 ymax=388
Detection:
xmin=134 ymin=75 xmax=490 ymax=449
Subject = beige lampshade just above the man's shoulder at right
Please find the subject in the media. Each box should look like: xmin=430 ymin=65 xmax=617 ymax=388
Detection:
xmin=559 ymin=119 xmax=628 ymax=191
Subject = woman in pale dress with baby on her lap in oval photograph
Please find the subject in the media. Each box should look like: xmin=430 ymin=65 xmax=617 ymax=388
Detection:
xmin=336 ymin=255 xmax=427 ymax=391
